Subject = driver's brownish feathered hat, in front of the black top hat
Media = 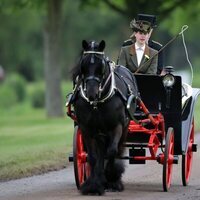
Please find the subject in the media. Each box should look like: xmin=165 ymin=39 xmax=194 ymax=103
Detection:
xmin=130 ymin=19 xmax=151 ymax=33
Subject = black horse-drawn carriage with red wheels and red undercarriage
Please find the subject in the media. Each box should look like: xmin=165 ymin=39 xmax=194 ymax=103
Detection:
xmin=67 ymin=70 xmax=200 ymax=191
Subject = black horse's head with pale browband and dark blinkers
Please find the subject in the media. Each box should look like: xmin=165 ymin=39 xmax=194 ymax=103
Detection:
xmin=80 ymin=40 xmax=107 ymax=102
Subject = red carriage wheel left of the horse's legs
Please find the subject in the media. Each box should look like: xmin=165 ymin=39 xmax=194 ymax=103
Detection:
xmin=73 ymin=126 xmax=90 ymax=189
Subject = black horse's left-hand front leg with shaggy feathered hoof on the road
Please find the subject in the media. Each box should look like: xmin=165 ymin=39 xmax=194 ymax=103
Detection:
xmin=80 ymin=138 xmax=105 ymax=195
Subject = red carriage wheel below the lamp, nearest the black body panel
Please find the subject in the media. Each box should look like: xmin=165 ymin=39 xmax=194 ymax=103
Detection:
xmin=163 ymin=127 xmax=174 ymax=192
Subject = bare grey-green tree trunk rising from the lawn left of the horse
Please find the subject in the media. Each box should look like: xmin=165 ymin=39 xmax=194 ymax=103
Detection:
xmin=44 ymin=0 xmax=63 ymax=117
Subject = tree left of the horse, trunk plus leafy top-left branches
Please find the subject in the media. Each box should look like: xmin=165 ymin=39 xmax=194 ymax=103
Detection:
xmin=0 ymin=0 xmax=63 ymax=117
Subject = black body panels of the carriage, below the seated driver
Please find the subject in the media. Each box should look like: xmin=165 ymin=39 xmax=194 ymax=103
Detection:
xmin=130 ymin=75 xmax=182 ymax=155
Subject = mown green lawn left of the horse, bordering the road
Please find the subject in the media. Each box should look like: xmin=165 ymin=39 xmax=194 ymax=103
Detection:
xmin=0 ymin=81 xmax=73 ymax=180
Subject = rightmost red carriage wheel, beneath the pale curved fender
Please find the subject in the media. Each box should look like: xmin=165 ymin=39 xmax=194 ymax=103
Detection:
xmin=182 ymin=119 xmax=194 ymax=186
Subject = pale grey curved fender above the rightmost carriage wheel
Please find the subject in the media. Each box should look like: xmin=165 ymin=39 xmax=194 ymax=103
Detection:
xmin=182 ymin=88 xmax=200 ymax=153
